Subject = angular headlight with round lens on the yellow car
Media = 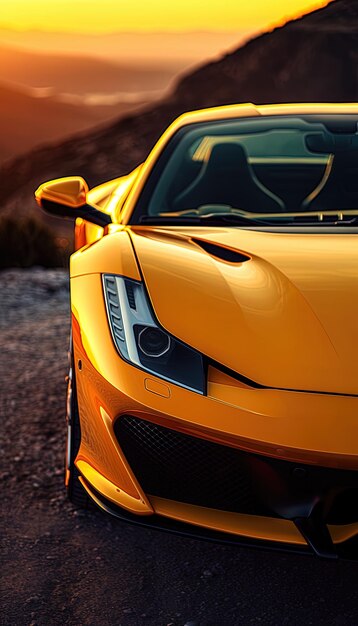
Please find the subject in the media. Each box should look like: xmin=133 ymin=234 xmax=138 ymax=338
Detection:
xmin=103 ymin=274 xmax=205 ymax=394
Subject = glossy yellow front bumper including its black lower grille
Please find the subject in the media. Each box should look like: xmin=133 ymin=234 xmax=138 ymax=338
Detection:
xmin=71 ymin=275 xmax=358 ymax=557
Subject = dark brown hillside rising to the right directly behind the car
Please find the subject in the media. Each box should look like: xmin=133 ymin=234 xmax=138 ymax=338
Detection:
xmin=0 ymin=0 xmax=358 ymax=217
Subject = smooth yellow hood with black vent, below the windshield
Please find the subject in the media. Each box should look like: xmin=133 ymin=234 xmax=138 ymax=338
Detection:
xmin=130 ymin=226 xmax=358 ymax=394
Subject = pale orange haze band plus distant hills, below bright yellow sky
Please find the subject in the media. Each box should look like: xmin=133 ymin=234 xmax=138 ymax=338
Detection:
xmin=0 ymin=28 xmax=246 ymax=161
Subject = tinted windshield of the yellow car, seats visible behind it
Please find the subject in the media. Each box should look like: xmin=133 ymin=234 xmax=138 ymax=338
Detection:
xmin=131 ymin=115 xmax=358 ymax=225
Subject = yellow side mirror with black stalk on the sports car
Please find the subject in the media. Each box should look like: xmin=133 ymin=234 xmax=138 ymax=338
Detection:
xmin=35 ymin=176 xmax=112 ymax=228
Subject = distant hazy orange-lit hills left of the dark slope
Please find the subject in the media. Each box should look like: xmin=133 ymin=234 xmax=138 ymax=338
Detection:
xmin=0 ymin=44 xmax=177 ymax=162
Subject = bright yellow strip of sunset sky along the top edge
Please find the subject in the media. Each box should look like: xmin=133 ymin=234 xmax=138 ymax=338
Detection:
xmin=0 ymin=0 xmax=328 ymax=33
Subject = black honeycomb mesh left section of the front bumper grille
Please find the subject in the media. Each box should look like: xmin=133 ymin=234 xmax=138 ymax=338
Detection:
xmin=115 ymin=415 xmax=272 ymax=515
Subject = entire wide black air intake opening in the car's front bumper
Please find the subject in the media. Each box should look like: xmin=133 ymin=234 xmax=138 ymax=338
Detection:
xmin=114 ymin=415 xmax=358 ymax=524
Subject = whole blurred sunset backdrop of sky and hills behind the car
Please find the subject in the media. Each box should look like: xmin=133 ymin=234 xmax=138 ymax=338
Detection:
xmin=0 ymin=0 xmax=358 ymax=267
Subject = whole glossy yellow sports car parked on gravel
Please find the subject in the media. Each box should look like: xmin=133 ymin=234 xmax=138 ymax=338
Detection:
xmin=36 ymin=104 xmax=358 ymax=558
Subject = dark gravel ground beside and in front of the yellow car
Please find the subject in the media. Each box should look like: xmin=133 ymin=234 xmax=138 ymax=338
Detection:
xmin=0 ymin=269 xmax=358 ymax=626
